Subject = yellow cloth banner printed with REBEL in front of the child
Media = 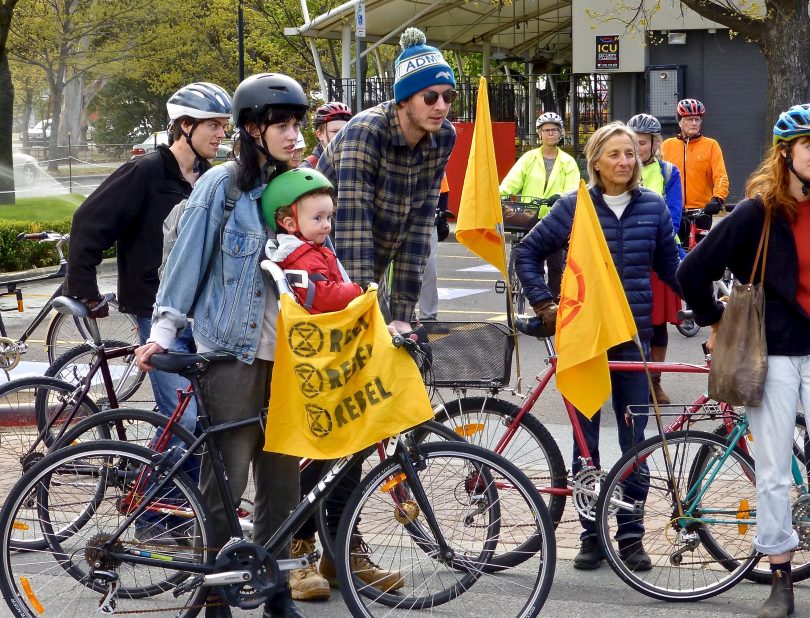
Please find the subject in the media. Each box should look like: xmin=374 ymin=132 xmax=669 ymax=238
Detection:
xmin=264 ymin=290 xmax=433 ymax=459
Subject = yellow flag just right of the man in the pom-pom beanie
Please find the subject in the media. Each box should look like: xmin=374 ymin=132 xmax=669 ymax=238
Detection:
xmin=456 ymin=77 xmax=508 ymax=280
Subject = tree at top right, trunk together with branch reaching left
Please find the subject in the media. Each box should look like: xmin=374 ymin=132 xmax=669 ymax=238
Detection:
xmin=681 ymin=0 xmax=810 ymax=121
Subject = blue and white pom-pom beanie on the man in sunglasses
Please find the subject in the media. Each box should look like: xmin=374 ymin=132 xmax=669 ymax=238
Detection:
xmin=394 ymin=28 xmax=456 ymax=103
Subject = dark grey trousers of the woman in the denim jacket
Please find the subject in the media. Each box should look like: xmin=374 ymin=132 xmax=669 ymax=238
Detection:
xmin=200 ymin=359 xmax=300 ymax=558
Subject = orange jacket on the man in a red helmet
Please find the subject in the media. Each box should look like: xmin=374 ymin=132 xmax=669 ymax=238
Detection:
xmin=661 ymin=135 xmax=728 ymax=208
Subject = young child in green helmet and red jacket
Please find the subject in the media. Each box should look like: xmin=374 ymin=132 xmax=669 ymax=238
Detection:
xmin=262 ymin=168 xmax=363 ymax=313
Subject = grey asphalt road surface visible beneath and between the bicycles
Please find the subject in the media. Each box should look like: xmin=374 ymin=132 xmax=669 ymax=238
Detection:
xmin=0 ymin=242 xmax=796 ymax=618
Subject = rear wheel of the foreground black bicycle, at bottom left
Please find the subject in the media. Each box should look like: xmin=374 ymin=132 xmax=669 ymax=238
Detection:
xmin=0 ymin=441 xmax=214 ymax=618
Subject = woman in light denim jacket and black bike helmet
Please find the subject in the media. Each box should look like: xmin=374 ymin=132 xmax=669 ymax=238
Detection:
xmin=136 ymin=73 xmax=309 ymax=618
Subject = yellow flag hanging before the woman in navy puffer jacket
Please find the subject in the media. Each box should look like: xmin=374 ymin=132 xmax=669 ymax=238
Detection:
xmin=556 ymin=181 xmax=636 ymax=418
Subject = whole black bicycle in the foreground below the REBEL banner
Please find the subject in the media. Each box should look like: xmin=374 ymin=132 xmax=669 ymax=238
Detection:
xmin=0 ymin=336 xmax=556 ymax=618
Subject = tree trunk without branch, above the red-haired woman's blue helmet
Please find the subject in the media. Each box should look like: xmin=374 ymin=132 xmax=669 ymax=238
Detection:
xmin=759 ymin=2 xmax=810 ymax=126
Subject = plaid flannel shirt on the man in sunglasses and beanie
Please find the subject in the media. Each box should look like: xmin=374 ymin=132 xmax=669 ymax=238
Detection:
xmin=318 ymin=101 xmax=456 ymax=322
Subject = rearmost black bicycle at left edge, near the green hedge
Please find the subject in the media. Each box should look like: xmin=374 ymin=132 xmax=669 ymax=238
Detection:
xmin=0 ymin=232 xmax=138 ymax=377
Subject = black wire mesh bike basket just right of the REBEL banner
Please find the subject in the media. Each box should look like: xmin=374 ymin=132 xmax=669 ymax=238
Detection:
xmin=422 ymin=321 xmax=515 ymax=389
